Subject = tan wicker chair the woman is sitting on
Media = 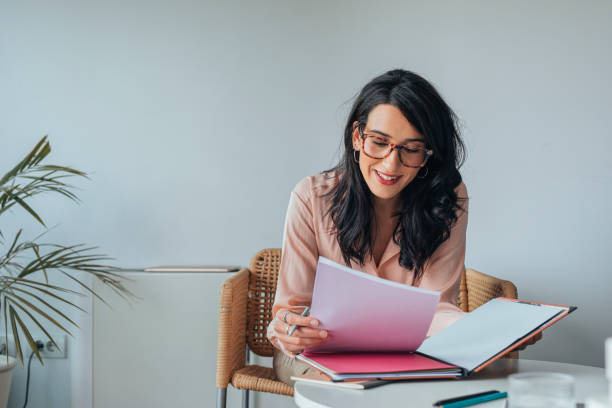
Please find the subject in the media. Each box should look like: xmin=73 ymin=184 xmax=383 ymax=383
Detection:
xmin=216 ymin=249 xmax=518 ymax=408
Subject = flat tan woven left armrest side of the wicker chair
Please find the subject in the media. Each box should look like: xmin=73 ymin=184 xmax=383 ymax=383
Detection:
xmin=216 ymin=268 xmax=250 ymax=388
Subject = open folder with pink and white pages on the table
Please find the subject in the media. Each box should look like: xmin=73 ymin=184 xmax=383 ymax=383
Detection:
xmin=297 ymin=257 xmax=576 ymax=381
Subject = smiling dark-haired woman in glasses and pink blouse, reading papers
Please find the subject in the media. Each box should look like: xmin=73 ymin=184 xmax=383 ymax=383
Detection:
xmin=268 ymin=70 xmax=536 ymax=384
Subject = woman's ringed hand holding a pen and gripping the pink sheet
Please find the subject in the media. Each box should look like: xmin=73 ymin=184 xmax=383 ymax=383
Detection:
xmin=268 ymin=309 xmax=327 ymax=356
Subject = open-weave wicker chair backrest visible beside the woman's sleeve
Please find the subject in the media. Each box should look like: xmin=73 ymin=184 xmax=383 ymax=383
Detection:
xmin=246 ymin=248 xmax=281 ymax=357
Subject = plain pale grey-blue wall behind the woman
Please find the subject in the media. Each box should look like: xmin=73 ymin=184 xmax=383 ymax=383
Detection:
xmin=0 ymin=0 xmax=612 ymax=406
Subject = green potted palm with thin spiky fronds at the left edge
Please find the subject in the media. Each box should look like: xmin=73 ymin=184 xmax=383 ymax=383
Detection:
xmin=0 ymin=136 xmax=131 ymax=366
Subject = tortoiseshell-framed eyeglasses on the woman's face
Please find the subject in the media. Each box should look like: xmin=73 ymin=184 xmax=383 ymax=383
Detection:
xmin=359 ymin=129 xmax=433 ymax=168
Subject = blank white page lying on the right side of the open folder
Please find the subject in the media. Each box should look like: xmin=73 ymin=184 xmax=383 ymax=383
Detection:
xmin=417 ymin=299 xmax=567 ymax=371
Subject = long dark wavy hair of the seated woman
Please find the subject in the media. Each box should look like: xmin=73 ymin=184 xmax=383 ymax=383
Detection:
xmin=328 ymin=69 xmax=465 ymax=284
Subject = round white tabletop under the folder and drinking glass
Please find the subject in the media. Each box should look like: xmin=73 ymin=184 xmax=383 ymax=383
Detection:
xmin=293 ymin=359 xmax=608 ymax=408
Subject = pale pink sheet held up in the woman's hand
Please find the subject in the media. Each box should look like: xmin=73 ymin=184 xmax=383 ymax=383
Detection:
xmin=307 ymin=257 xmax=440 ymax=352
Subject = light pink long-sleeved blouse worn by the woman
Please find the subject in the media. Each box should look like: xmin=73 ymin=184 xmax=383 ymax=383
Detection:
xmin=272 ymin=173 xmax=468 ymax=343
